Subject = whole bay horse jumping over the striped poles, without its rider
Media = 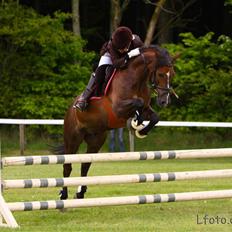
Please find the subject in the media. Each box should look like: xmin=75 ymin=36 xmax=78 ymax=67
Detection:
xmin=60 ymin=46 xmax=174 ymax=199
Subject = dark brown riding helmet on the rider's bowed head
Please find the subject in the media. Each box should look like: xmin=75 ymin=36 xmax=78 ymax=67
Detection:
xmin=112 ymin=27 xmax=133 ymax=49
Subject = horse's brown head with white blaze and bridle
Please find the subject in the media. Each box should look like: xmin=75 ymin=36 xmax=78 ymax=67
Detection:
xmin=140 ymin=46 xmax=175 ymax=107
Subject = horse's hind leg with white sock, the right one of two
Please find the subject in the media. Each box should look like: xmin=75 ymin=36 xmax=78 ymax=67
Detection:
xmin=74 ymin=132 xmax=107 ymax=199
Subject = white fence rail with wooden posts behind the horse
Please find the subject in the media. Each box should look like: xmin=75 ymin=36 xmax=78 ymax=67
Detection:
xmin=0 ymin=118 xmax=232 ymax=155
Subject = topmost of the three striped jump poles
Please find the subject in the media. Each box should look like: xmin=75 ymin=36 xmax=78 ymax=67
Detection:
xmin=2 ymin=148 xmax=232 ymax=166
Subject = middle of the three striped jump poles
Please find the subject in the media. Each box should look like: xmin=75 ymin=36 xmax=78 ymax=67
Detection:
xmin=3 ymin=169 xmax=232 ymax=189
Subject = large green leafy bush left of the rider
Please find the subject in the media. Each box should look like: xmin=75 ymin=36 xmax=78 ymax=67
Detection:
xmin=0 ymin=2 xmax=95 ymax=118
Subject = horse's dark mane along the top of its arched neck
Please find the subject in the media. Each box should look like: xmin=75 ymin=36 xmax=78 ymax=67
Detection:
xmin=140 ymin=45 xmax=172 ymax=67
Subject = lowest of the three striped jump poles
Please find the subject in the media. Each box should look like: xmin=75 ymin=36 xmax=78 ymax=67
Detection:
xmin=7 ymin=189 xmax=232 ymax=211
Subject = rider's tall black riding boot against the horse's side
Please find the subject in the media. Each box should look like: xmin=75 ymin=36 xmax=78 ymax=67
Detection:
xmin=73 ymin=73 xmax=95 ymax=111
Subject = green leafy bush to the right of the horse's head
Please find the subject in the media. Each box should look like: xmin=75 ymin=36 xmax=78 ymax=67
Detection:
xmin=160 ymin=32 xmax=232 ymax=121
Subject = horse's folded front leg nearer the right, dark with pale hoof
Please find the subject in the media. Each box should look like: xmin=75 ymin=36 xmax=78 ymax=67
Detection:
xmin=136 ymin=106 xmax=159 ymax=138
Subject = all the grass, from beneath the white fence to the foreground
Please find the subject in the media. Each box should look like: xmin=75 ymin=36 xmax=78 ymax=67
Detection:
xmin=1 ymin=128 xmax=232 ymax=232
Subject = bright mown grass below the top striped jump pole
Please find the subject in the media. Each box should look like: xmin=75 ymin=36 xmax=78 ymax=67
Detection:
xmin=1 ymin=158 xmax=232 ymax=231
